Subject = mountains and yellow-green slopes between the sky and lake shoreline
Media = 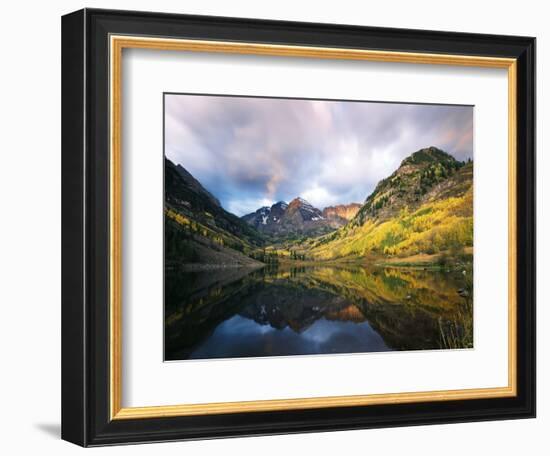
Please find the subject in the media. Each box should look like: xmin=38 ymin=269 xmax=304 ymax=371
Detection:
xmin=165 ymin=147 xmax=473 ymax=270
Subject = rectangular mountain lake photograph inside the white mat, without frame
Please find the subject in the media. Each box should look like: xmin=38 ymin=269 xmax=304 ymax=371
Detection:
xmin=164 ymin=93 xmax=474 ymax=361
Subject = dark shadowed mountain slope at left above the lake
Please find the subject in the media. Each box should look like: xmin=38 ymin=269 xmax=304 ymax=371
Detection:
xmin=164 ymin=158 xmax=265 ymax=266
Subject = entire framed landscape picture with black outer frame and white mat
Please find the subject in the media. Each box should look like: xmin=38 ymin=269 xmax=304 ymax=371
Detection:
xmin=62 ymin=9 xmax=535 ymax=446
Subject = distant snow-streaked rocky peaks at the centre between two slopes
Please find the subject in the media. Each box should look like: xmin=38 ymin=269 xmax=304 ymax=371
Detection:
xmin=242 ymin=197 xmax=346 ymax=240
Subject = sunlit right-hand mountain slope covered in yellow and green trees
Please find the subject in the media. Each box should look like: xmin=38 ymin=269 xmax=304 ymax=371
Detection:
xmin=302 ymin=147 xmax=473 ymax=260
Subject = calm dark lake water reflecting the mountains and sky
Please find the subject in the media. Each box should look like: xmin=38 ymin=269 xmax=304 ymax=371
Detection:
xmin=165 ymin=266 xmax=473 ymax=360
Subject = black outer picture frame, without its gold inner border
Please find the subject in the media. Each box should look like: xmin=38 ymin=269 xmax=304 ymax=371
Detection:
xmin=62 ymin=9 xmax=536 ymax=446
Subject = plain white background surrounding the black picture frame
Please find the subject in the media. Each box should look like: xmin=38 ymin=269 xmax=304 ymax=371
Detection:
xmin=0 ymin=0 xmax=550 ymax=456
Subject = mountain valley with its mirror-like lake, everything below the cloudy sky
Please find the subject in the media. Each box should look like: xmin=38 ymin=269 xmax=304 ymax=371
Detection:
xmin=165 ymin=147 xmax=473 ymax=360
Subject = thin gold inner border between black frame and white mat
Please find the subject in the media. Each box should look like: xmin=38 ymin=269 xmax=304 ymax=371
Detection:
xmin=109 ymin=35 xmax=517 ymax=420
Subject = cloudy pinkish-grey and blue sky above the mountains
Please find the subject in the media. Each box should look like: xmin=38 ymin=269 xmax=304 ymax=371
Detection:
xmin=165 ymin=94 xmax=473 ymax=216
